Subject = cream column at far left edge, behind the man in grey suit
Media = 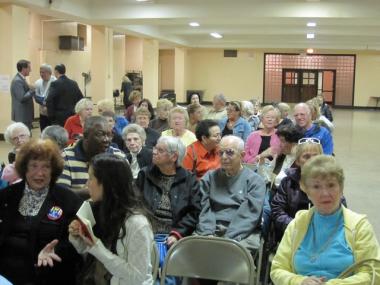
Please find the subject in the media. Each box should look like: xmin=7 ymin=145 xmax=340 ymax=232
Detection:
xmin=0 ymin=5 xmax=29 ymax=133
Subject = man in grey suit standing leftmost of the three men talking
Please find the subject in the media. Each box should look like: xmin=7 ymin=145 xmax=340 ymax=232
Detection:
xmin=11 ymin=59 xmax=34 ymax=129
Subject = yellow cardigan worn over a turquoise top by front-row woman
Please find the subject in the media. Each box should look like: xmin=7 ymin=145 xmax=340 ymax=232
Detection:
xmin=271 ymin=206 xmax=380 ymax=285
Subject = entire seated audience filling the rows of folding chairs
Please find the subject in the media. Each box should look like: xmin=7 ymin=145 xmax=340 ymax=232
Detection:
xmin=0 ymin=90 xmax=380 ymax=285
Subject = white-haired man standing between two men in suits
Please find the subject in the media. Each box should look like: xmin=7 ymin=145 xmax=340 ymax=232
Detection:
xmin=34 ymin=63 xmax=56 ymax=132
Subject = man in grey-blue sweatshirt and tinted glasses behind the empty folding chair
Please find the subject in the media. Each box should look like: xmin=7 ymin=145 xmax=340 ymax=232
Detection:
xmin=196 ymin=135 xmax=265 ymax=251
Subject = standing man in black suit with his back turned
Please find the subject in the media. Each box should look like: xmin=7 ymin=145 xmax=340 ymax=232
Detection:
xmin=46 ymin=64 xmax=83 ymax=127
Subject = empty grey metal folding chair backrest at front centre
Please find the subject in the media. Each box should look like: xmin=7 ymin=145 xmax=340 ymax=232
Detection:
xmin=161 ymin=236 xmax=255 ymax=285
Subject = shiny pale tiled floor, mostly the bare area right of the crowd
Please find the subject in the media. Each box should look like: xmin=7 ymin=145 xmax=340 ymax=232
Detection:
xmin=0 ymin=110 xmax=380 ymax=238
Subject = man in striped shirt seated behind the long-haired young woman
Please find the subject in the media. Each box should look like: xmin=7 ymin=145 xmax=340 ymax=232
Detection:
xmin=57 ymin=116 xmax=126 ymax=197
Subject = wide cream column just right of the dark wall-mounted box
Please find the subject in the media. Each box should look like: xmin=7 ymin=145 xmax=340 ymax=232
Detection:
xmin=87 ymin=26 xmax=113 ymax=103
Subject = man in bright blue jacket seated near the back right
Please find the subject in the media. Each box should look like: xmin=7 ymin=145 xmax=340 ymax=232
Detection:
xmin=293 ymin=103 xmax=334 ymax=155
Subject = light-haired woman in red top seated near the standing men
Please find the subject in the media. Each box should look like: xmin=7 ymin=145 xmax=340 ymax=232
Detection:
xmin=64 ymin=98 xmax=94 ymax=144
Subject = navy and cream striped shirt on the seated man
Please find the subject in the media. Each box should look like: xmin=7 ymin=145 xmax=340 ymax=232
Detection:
xmin=57 ymin=140 xmax=127 ymax=190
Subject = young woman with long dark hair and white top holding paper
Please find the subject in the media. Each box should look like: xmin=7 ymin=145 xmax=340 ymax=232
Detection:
xmin=69 ymin=153 xmax=153 ymax=285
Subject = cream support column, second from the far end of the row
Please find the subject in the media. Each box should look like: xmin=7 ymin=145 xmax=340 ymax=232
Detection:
xmin=142 ymin=39 xmax=159 ymax=106
